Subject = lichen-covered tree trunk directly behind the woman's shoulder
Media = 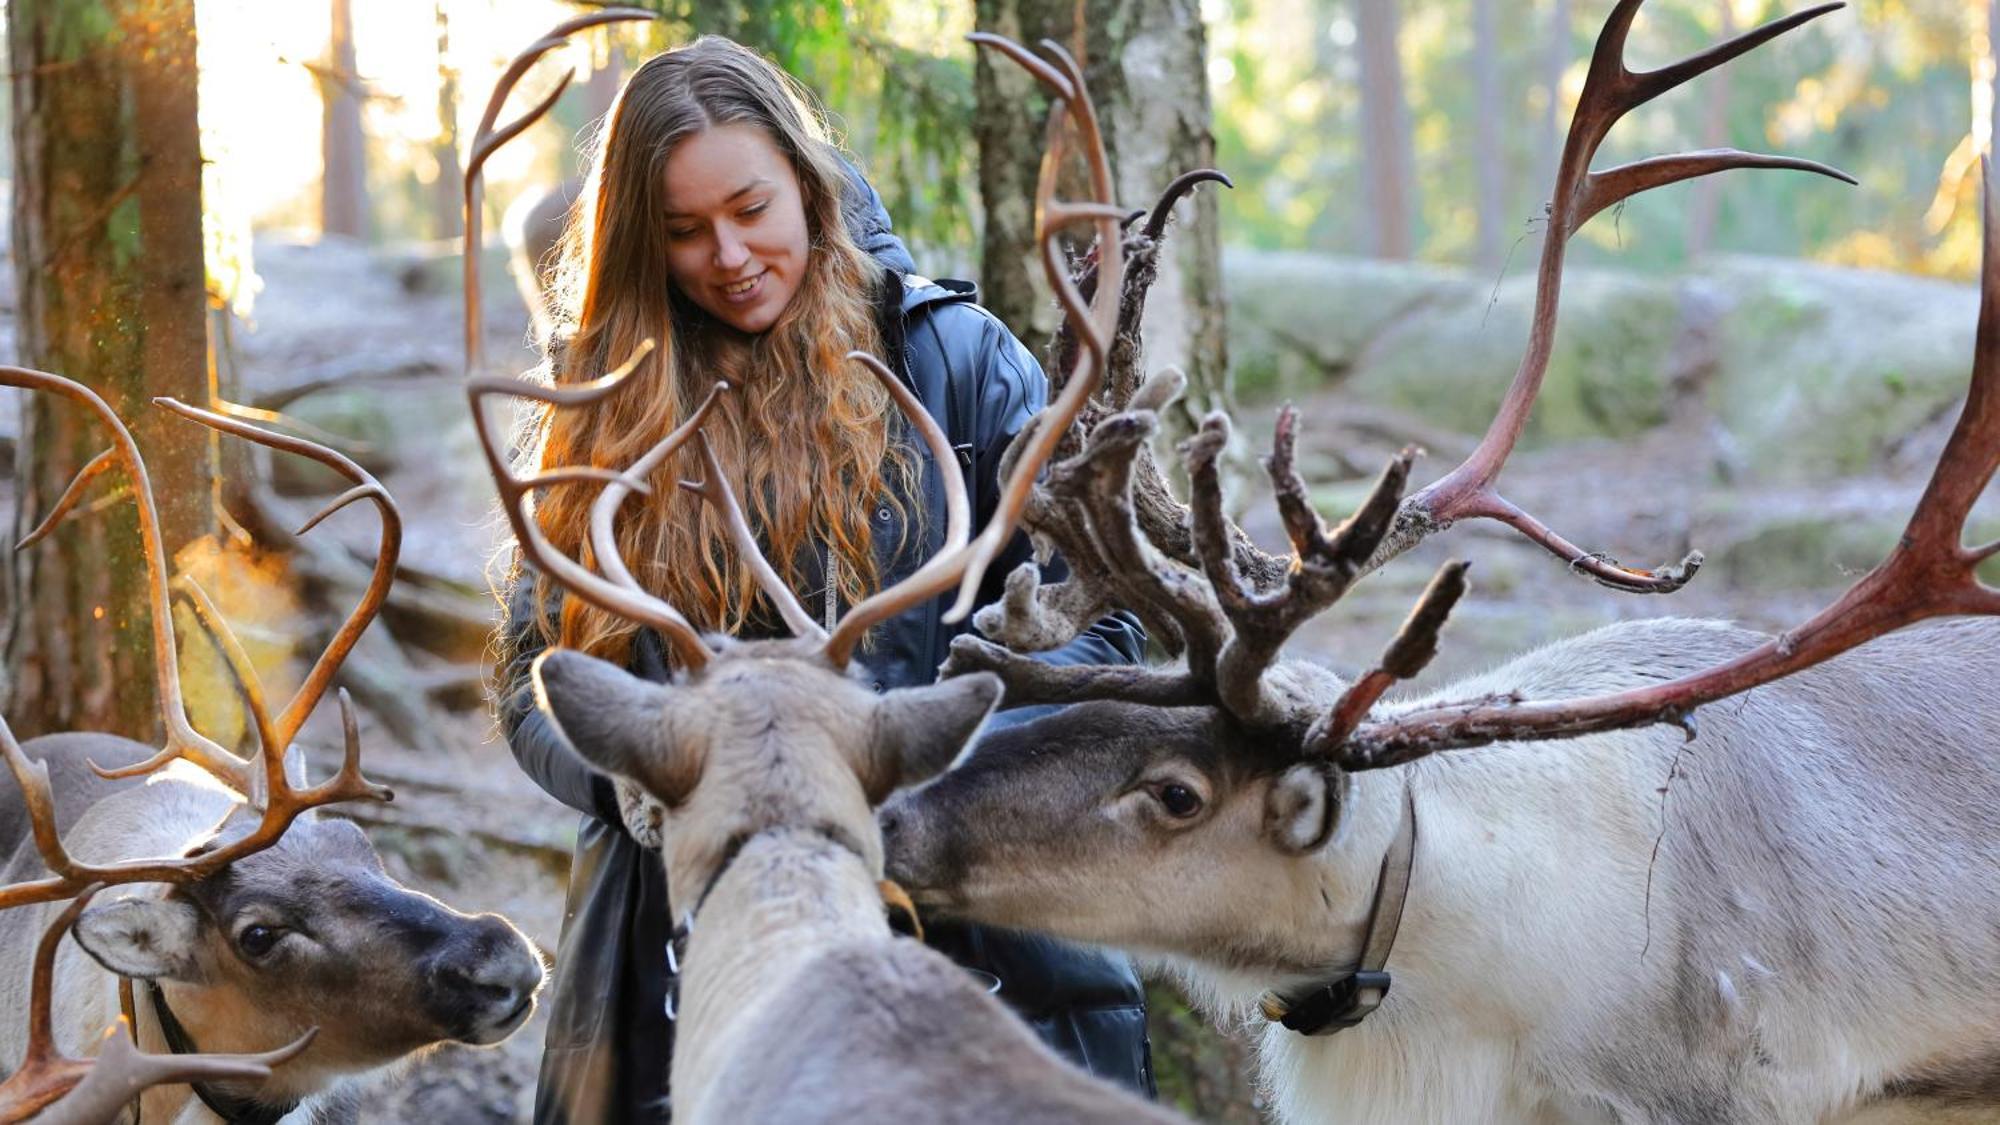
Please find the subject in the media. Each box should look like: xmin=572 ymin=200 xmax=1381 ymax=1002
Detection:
xmin=974 ymin=0 xmax=1228 ymax=416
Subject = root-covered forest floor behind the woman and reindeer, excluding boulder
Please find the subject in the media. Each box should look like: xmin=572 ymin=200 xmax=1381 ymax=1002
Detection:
xmin=7 ymin=238 xmax=1992 ymax=1125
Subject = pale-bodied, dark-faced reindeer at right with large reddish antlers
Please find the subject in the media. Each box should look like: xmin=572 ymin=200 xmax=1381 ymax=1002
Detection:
xmin=882 ymin=0 xmax=2000 ymax=1125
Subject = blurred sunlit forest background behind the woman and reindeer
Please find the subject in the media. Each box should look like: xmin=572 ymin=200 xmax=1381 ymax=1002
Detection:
xmin=0 ymin=0 xmax=2000 ymax=1123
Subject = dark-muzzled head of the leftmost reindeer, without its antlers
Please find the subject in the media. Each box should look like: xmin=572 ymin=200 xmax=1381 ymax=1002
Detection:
xmin=74 ymin=797 xmax=542 ymax=1064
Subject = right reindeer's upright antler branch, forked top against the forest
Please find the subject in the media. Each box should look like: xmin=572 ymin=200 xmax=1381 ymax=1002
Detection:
xmin=1368 ymin=0 xmax=1854 ymax=593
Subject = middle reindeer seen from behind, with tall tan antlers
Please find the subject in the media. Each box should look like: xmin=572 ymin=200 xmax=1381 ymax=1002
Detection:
xmin=466 ymin=13 xmax=1178 ymax=1123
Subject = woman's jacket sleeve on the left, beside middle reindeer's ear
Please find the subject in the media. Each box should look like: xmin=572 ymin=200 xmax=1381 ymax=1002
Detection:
xmin=496 ymin=577 xmax=624 ymax=831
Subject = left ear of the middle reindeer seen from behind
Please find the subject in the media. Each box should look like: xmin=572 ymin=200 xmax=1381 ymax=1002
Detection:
xmin=532 ymin=649 xmax=700 ymax=805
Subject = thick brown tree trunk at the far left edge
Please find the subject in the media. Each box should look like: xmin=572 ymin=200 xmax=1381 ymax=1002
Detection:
xmin=4 ymin=0 xmax=214 ymax=741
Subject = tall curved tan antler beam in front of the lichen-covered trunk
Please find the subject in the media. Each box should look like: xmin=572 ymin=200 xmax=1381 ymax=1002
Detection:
xmin=944 ymin=34 xmax=1124 ymax=623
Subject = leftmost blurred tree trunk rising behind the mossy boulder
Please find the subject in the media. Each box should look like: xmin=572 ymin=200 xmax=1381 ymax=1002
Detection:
xmin=1354 ymin=0 xmax=1416 ymax=258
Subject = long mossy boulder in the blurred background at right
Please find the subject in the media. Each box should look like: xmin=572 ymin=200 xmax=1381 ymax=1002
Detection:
xmin=1224 ymin=248 xmax=1978 ymax=480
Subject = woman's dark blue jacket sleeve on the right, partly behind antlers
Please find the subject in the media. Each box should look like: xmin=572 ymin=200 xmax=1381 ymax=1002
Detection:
xmin=956 ymin=304 xmax=1146 ymax=665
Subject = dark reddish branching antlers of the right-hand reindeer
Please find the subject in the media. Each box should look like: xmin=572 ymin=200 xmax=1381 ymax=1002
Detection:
xmin=948 ymin=0 xmax=2000 ymax=788
